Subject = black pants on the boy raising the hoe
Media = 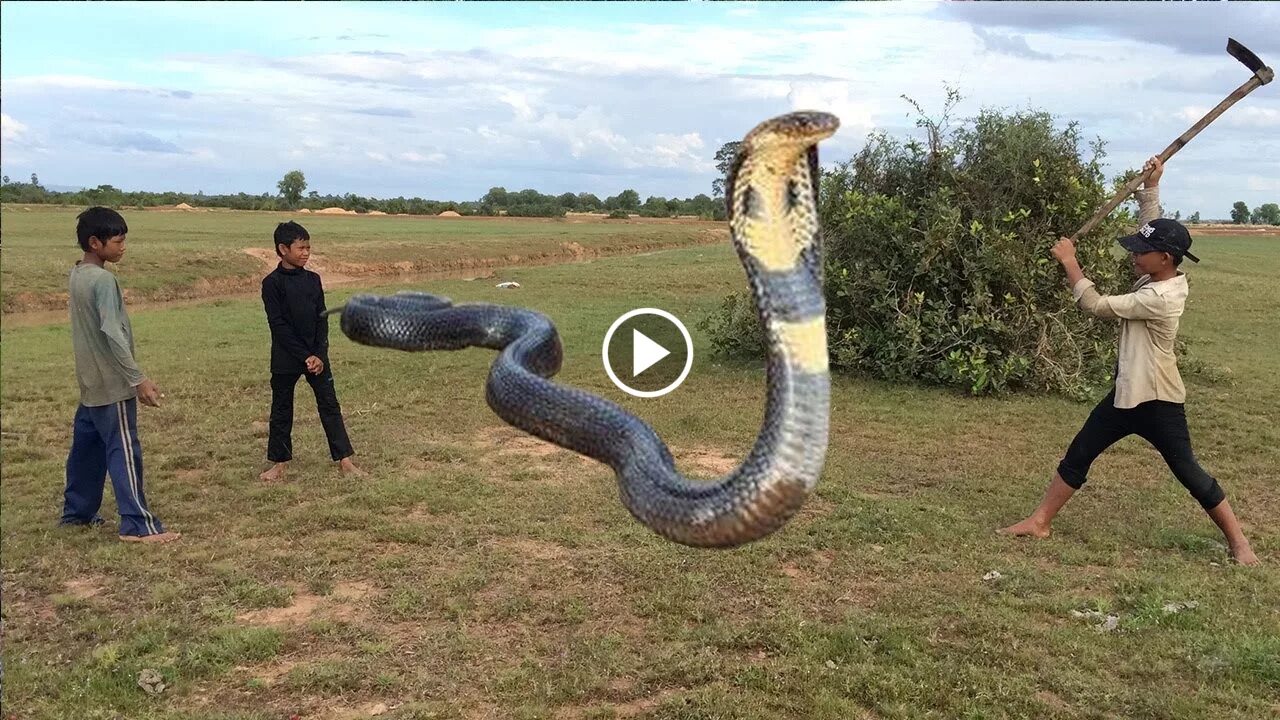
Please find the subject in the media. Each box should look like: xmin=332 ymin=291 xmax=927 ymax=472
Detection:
xmin=1057 ymin=389 xmax=1226 ymax=510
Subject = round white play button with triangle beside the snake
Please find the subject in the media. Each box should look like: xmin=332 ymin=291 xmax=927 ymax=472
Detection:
xmin=602 ymin=307 xmax=694 ymax=397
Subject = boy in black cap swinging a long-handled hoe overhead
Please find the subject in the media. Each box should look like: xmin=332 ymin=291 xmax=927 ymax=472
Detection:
xmin=1000 ymin=40 xmax=1275 ymax=565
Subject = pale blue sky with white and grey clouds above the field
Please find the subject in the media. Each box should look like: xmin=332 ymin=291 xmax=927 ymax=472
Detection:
xmin=0 ymin=3 xmax=1280 ymax=218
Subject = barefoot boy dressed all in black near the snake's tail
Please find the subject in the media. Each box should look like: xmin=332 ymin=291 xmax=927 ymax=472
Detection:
xmin=259 ymin=222 xmax=364 ymax=480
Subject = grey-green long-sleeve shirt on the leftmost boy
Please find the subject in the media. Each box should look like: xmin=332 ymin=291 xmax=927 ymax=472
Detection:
xmin=69 ymin=263 xmax=143 ymax=407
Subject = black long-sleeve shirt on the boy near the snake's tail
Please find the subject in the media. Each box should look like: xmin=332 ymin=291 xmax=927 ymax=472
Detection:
xmin=262 ymin=264 xmax=329 ymax=373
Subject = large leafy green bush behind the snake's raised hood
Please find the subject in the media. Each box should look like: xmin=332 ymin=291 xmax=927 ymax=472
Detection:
xmin=703 ymin=91 xmax=1133 ymax=398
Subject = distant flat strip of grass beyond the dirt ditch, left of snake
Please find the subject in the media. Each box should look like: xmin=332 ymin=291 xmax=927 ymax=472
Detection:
xmin=0 ymin=205 xmax=728 ymax=313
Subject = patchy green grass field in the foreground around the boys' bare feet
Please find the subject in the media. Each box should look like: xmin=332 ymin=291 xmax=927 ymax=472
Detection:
xmin=0 ymin=203 xmax=1280 ymax=720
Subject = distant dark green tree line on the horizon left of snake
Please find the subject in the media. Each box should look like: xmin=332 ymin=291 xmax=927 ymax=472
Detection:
xmin=0 ymin=170 xmax=724 ymax=220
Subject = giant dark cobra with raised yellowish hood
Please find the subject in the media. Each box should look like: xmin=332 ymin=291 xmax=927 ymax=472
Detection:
xmin=335 ymin=113 xmax=838 ymax=547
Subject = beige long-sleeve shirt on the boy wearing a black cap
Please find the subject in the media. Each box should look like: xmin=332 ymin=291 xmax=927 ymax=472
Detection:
xmin=1071 ymin=187 xmax=1188 ymax=409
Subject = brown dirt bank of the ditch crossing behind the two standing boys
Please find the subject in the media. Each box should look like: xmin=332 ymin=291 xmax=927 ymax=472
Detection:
xmin=4 ymin=229 xmax=728 ymax=317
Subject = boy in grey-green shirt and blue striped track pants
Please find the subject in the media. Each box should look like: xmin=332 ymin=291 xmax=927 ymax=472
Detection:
xmin=61 ymin=208 xmax=182 ymax=543
